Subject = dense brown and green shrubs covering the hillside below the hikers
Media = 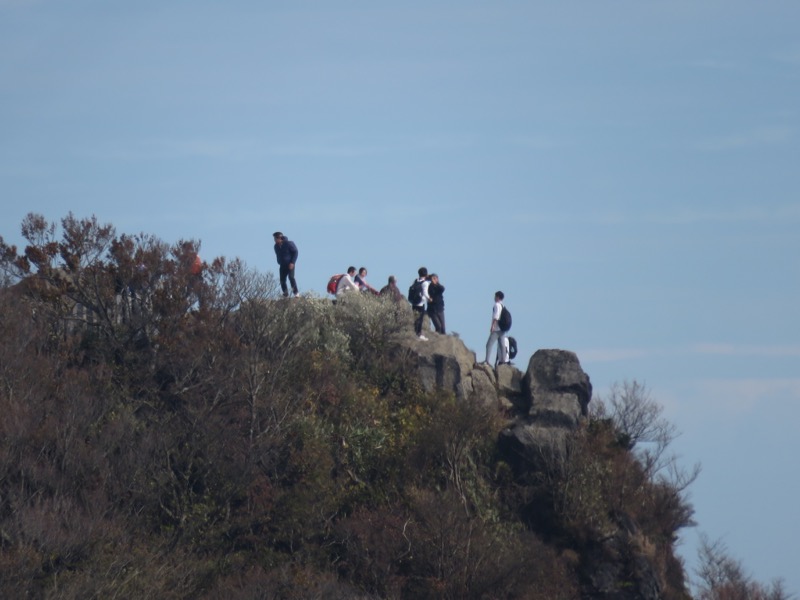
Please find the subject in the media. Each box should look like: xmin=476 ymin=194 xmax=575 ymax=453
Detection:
xmin=0 ymin=215 xmax=779 ymax=600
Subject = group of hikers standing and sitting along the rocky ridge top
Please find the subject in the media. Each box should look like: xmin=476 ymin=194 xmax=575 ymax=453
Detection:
xmin=273 ymin=231 xmax=516 ymax=365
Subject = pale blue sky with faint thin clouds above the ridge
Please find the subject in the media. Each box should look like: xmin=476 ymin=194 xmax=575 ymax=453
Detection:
xmin=0 ymin=0 xmax=800 ymax=593
